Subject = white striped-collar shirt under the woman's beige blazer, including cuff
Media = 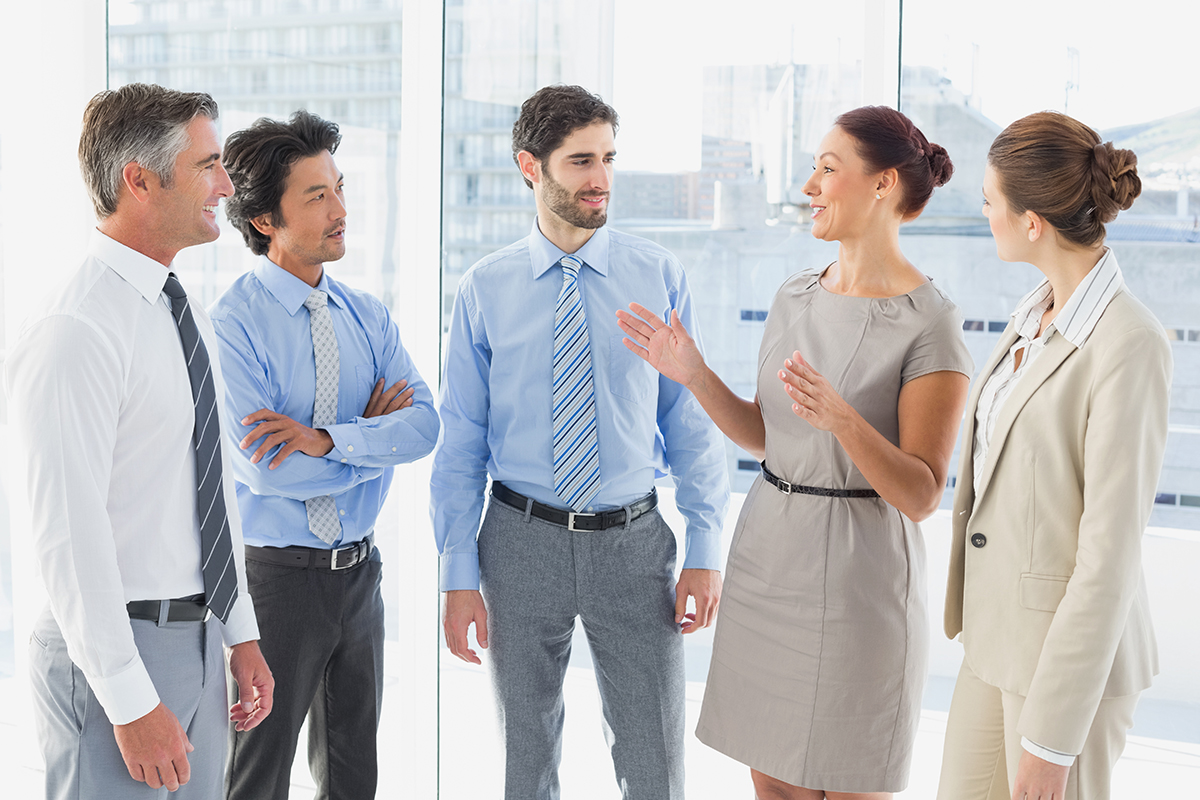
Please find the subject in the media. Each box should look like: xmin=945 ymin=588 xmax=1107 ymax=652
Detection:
xmin=973 ymin=249 xmax=1124 ymax=766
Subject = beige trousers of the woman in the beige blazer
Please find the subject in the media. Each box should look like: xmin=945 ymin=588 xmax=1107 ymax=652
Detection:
xmin=937 ymin=661 xmax=1140 ymax=800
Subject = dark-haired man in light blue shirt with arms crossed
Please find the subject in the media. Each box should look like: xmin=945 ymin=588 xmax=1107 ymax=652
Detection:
xmin=212 ymin=110 xmax=439 ymax=800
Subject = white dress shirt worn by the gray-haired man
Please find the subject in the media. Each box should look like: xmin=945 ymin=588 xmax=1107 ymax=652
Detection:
xmin=7 ymin=231 xmax=258 ymax=724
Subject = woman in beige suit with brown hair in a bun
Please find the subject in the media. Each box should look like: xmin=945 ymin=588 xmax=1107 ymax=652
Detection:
xmin=938 ymin=113 xmax=1171 ymax=800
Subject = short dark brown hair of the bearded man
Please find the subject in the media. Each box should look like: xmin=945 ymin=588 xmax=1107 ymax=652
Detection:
xmin=512 ymin=84 xmax=619 ymax=188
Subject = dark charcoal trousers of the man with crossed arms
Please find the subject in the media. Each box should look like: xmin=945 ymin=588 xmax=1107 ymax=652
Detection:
xmin=226 ymin=551 xmax=384 ymax=800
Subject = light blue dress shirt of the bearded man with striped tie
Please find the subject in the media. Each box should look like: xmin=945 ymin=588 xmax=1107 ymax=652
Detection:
xmin=430 ymin=222 xmax=730 ymax=591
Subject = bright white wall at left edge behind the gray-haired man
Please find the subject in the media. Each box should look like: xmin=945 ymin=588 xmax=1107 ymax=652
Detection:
xmin=0 ymin=0 xmax=106 ymax=729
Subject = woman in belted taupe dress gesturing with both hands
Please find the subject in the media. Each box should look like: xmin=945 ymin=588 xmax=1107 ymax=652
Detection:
xmin=618 ymin=107 xmax=972 ymax=800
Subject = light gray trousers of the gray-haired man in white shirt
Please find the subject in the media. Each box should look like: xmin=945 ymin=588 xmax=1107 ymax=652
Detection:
xmin=29 ymin=607 xmax=229 ymax=800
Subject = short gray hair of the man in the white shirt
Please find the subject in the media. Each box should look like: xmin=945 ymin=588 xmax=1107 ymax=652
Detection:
xmin=79 ymin=83 xmax=218 ymax=219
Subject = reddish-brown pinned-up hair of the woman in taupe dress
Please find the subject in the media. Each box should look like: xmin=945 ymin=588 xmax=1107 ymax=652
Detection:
xmin=834 ymin=106 xmax=954 ymax=218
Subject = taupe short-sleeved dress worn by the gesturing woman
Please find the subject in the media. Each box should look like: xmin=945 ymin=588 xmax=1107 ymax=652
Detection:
xmin=696 ymin=267 xmax=972 ymax=792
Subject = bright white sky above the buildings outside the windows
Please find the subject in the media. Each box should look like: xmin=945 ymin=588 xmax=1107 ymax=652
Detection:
xmin=109 ymin=0 xmax=1200 ymax=172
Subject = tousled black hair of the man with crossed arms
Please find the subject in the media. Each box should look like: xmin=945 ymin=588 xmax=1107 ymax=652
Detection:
xmin=223 ymin=108 xmax=342 ymax=255
